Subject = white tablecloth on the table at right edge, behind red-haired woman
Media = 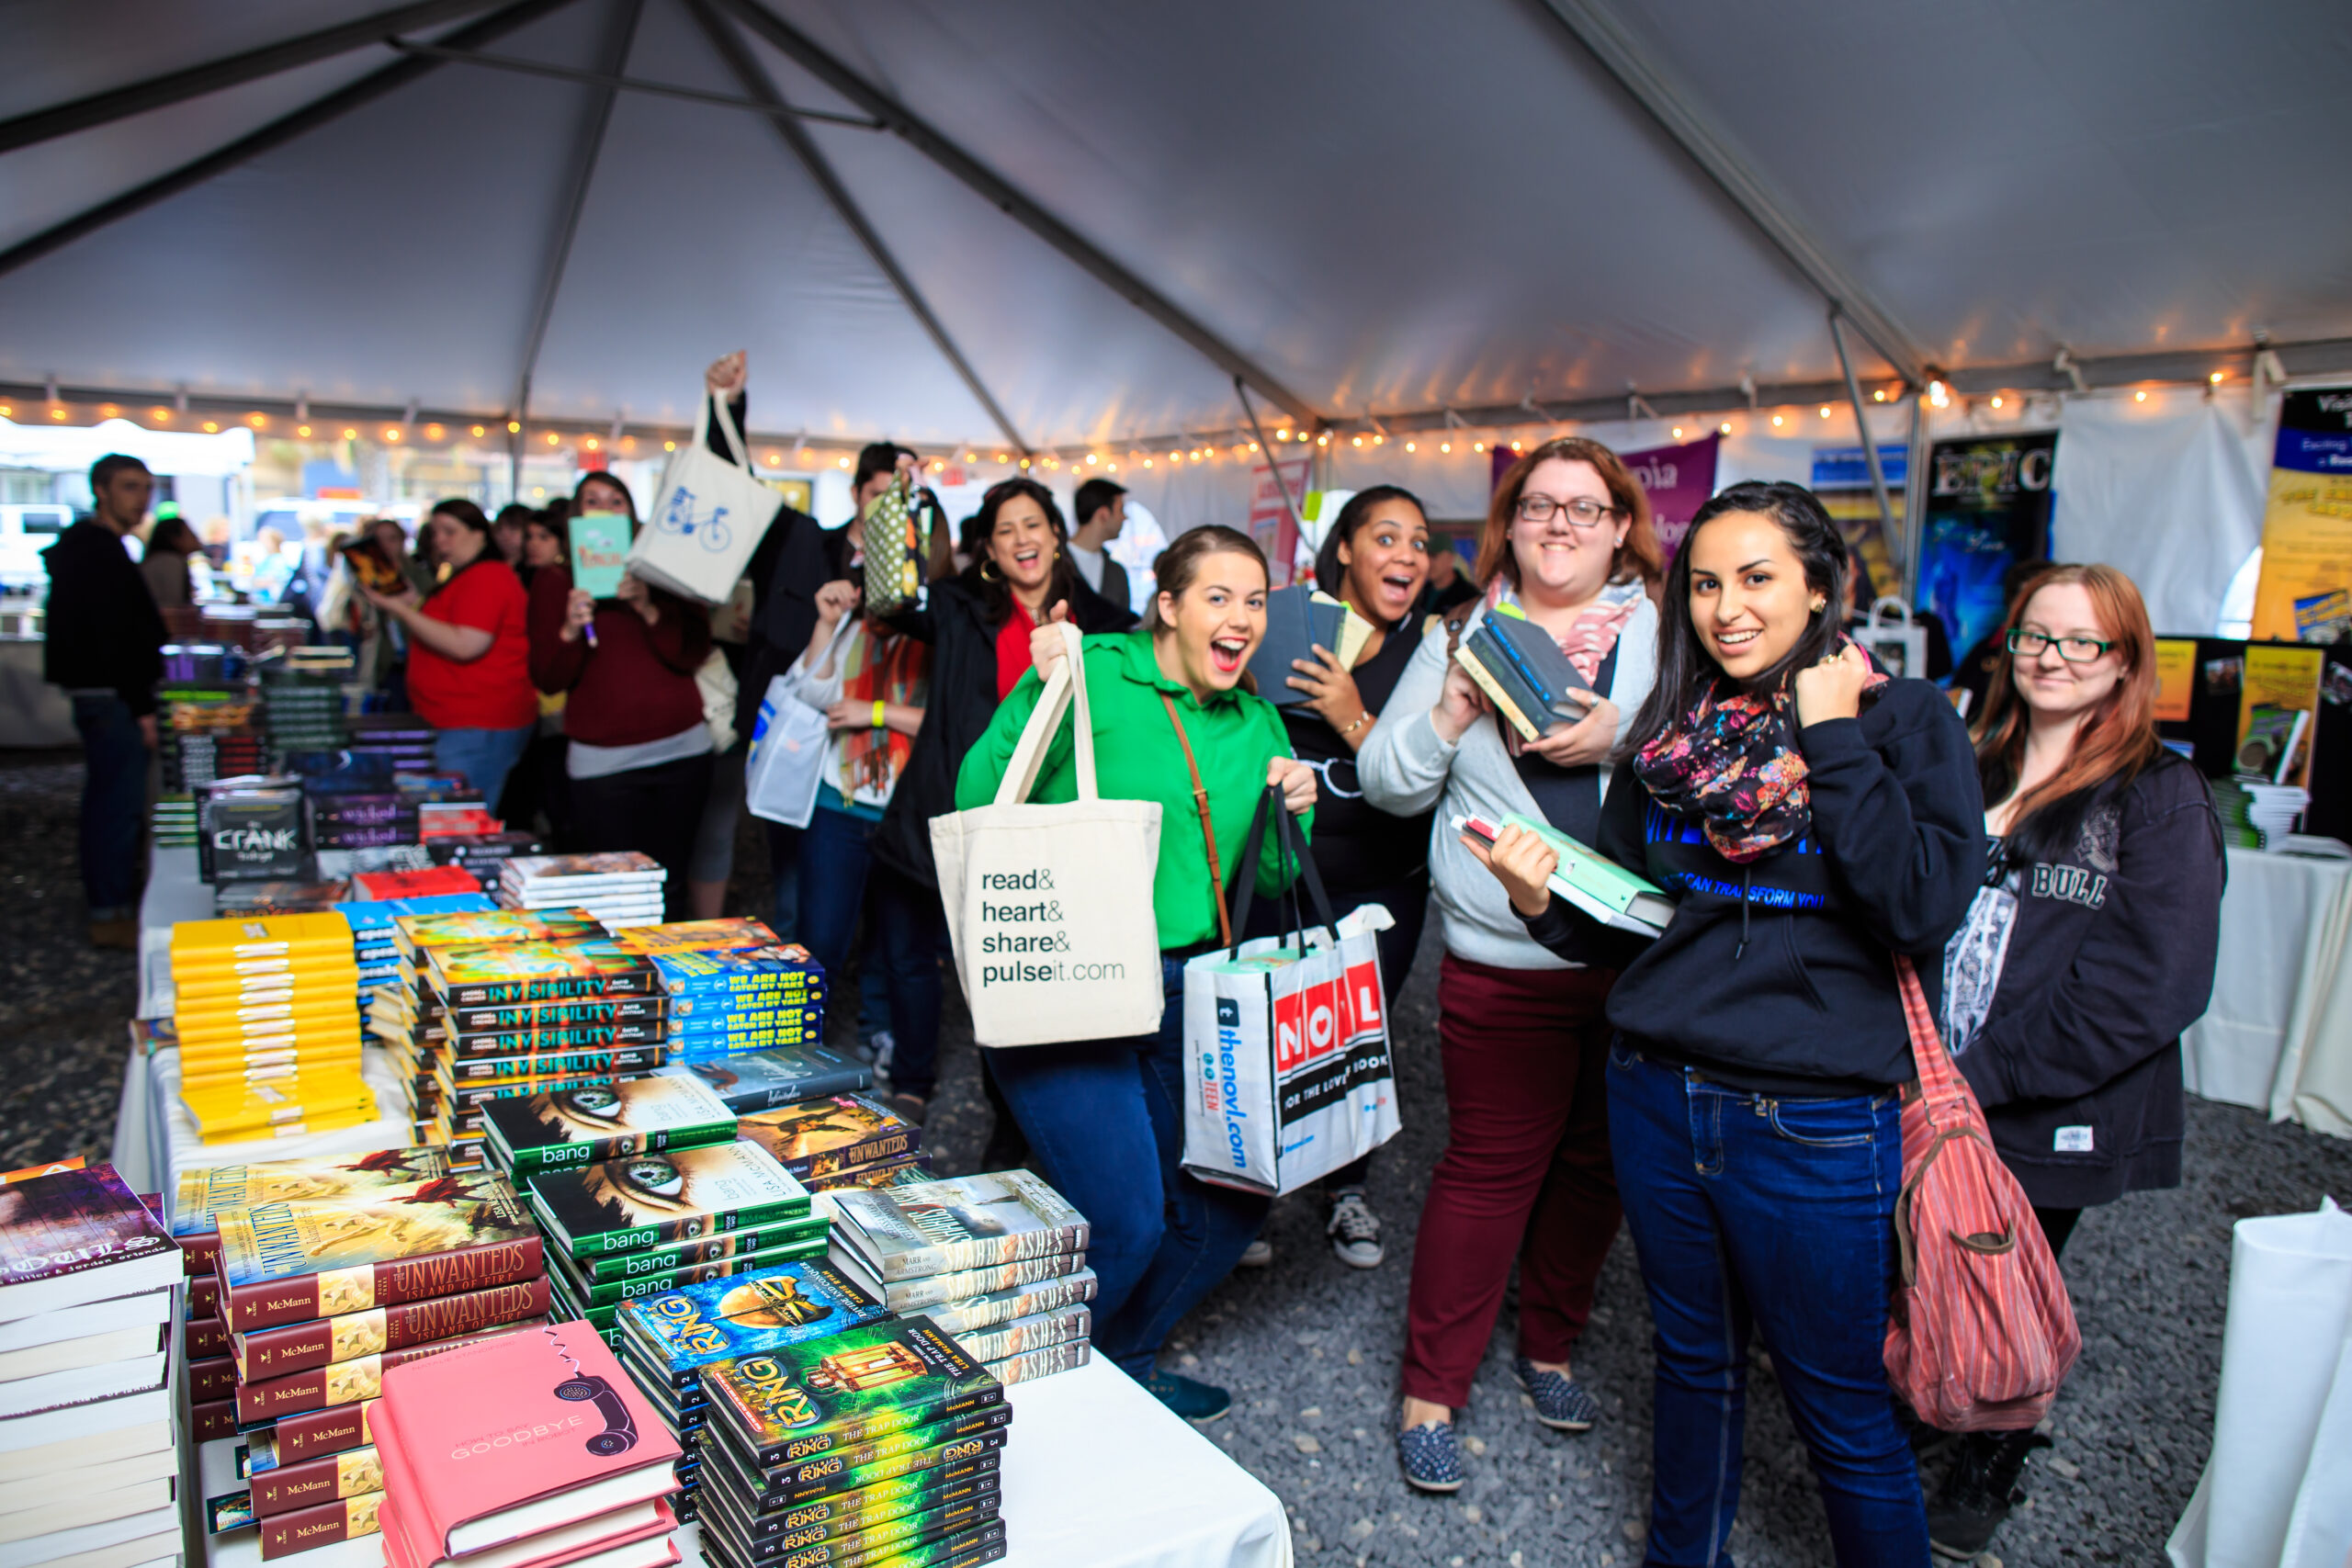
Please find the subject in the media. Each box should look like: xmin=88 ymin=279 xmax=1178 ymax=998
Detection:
xmin=2180 ymin=849 xmax=2352 ymax=1138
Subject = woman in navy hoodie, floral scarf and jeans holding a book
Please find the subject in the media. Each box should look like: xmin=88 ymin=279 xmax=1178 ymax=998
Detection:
xmin=1470 ymin=484 xmax=1985 ymax=1568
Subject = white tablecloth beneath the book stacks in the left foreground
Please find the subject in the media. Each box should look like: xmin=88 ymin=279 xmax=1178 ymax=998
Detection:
xmin=198 ymin=1361 xmax=1291 ymax=1568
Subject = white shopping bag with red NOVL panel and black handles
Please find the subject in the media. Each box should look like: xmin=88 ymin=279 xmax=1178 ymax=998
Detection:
xmin=1183 ymin=787 xmax=1399 ymax=1197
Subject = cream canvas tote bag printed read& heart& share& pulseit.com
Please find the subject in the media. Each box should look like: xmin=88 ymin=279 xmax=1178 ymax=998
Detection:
xmin=932 ymin=623 xmax=1164 ymax=1046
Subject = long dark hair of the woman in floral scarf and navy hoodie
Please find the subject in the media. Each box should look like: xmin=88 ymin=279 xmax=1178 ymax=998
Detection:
xmin=1618 ymin=479 xmax=1847 ymax=757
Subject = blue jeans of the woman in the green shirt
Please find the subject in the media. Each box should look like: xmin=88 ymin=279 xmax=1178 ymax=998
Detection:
xmin=988 ymin=957 xmax=1270 ymax=1380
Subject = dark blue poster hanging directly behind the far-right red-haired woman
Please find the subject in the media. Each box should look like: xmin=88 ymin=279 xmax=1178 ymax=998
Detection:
xmin=1919 ymin=430 xmax=2058 ymax=671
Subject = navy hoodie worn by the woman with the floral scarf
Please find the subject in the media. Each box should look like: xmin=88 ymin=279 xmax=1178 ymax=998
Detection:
xmin=1529 ymin=680 xmax=1985 ymax=1096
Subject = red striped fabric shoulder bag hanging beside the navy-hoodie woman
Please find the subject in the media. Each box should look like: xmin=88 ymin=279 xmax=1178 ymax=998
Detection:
xmin=1886 ymin=954 xmax=2082 ymax=1432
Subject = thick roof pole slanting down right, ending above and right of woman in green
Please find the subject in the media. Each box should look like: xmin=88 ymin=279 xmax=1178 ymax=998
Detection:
xmin=719 ymin=0 xmax=1322 ymax=425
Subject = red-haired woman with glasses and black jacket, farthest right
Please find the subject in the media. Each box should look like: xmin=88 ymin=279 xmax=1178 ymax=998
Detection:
xmin=1928 ymin=567 xmax=2222 ymax=1556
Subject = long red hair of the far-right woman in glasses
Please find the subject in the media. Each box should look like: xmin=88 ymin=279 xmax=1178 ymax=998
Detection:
xmin=1975 ymin=562 xmax=2164 ymax=865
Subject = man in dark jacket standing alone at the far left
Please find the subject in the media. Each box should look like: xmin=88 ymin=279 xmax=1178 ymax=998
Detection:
xmin=42 ymin=454 xmax=164 ymax=947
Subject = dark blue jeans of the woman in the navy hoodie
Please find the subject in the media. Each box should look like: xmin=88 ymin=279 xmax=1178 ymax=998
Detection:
xmin=1609 ymin=1037 xmax=1928 ymax=1568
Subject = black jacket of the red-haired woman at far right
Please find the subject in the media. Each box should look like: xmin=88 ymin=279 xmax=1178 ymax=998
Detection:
xmin=1959 ymin=752 xmax=2227 ymax=1208
